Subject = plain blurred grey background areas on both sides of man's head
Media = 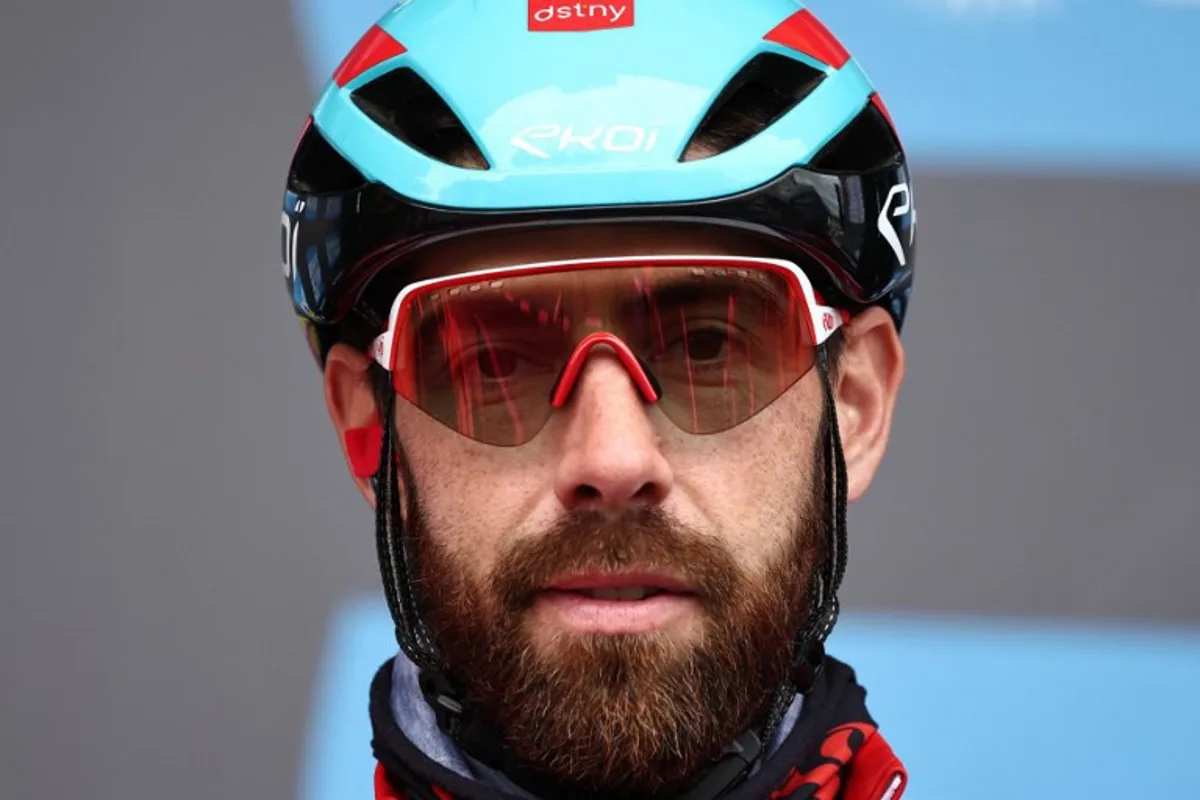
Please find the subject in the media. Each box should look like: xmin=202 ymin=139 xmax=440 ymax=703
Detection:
xmin=0 ymin=0 xmax=1200 ymax=800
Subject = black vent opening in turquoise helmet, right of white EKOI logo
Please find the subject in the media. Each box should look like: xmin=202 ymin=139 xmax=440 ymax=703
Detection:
xmin=679 ymin=53 xmax=824 ymax=161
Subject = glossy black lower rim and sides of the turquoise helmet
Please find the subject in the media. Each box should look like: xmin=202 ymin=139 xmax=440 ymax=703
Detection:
xmin=282 ymin=104 xmax=916 ymax=363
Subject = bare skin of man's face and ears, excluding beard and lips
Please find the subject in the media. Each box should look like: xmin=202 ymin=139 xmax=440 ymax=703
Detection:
xmin=325 ymin=227 xmax=905 ymax=786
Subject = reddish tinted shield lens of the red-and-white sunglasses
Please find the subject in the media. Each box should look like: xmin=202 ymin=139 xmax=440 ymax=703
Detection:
xmin=396 ymin=265 xmax=815 ymax=445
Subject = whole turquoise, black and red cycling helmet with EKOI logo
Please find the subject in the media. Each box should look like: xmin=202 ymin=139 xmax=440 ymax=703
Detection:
xmin=283 ymin=0 xmax=916 ymax=362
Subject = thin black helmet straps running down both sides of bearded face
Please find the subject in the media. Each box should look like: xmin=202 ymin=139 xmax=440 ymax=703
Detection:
xmin=371 ymin=345 xmax=847 ymax=800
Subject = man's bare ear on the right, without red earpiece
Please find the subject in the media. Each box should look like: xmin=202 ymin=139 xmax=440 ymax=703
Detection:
xmin=834 ymin=306 xmax=905 ymax=503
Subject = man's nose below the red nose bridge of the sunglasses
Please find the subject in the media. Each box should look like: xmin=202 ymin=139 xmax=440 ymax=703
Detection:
xmin=554 ymin=348 xmax=674 ymax=509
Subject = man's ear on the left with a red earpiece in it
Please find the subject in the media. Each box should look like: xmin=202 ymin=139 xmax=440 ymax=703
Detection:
xmin=325 ymin=344 xmax=383 ymax=509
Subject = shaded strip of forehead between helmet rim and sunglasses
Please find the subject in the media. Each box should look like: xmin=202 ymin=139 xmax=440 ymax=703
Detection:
xmin=412 ymin=223 xmax=772 ymax=279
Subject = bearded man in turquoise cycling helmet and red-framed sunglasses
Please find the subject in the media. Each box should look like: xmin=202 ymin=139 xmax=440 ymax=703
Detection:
xmin=283 ymin=0 xmax=914 ymax=800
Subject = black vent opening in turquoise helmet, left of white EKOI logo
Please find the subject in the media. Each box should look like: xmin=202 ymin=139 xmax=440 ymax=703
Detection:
xmin=353 ymin=67 xmax=488 ymax=169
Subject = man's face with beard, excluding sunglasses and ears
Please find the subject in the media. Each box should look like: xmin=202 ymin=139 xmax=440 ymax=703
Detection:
xmin=331 ymin=229 xmax=902 ymax=795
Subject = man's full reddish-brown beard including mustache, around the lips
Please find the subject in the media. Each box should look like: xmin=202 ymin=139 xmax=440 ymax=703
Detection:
xmin=401 ymin=458 xmax=826 ymax=798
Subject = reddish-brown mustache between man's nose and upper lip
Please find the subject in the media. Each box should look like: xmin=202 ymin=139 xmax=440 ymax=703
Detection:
xmin=490 ymin=506 xmax=739 ymax=613
